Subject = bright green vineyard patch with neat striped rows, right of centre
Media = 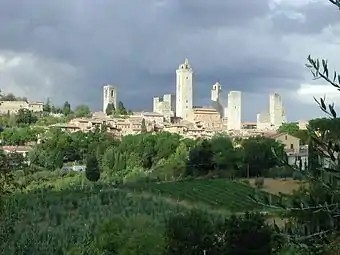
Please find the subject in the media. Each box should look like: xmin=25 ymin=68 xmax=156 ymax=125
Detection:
xmin=126 ymin=179 xmax=275 ymax=212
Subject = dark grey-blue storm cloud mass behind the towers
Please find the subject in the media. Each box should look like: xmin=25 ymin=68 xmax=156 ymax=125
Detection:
xmin=0 ymin=0 xmax=330 ymax=113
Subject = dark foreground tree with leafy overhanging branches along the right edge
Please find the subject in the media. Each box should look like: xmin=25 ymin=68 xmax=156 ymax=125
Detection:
xmin=251 ymin=0 xmax=340 ymax=254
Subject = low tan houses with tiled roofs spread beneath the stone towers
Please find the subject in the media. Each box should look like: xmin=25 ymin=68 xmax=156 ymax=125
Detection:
xmin=3 ymin=108 xmax=316 ymax=171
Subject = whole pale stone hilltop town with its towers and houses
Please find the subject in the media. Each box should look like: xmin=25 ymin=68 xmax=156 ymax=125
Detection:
xmin=0 ymin=59 xmax=307 ymax=138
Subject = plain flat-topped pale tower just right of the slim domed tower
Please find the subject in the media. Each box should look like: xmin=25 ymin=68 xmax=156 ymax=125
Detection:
xmin=228 ymin=91 xmax=242 ymax=130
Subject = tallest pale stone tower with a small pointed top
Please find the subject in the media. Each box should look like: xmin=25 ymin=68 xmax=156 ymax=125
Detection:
xmin=176 ymin=59 xmax=193 ymax=119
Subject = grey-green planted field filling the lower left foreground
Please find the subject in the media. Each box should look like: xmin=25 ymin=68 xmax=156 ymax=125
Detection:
xmin=0 ymin=186 xmax=189 ymax=255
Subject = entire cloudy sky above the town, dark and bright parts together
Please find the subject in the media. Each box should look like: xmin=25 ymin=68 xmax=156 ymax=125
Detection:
xmin=0 ymin=0 xmax=340 ymax=121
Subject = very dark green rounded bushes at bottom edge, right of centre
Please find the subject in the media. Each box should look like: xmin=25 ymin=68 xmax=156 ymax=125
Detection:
xmin=165 ymin=211 xmax=281 ymax=255
